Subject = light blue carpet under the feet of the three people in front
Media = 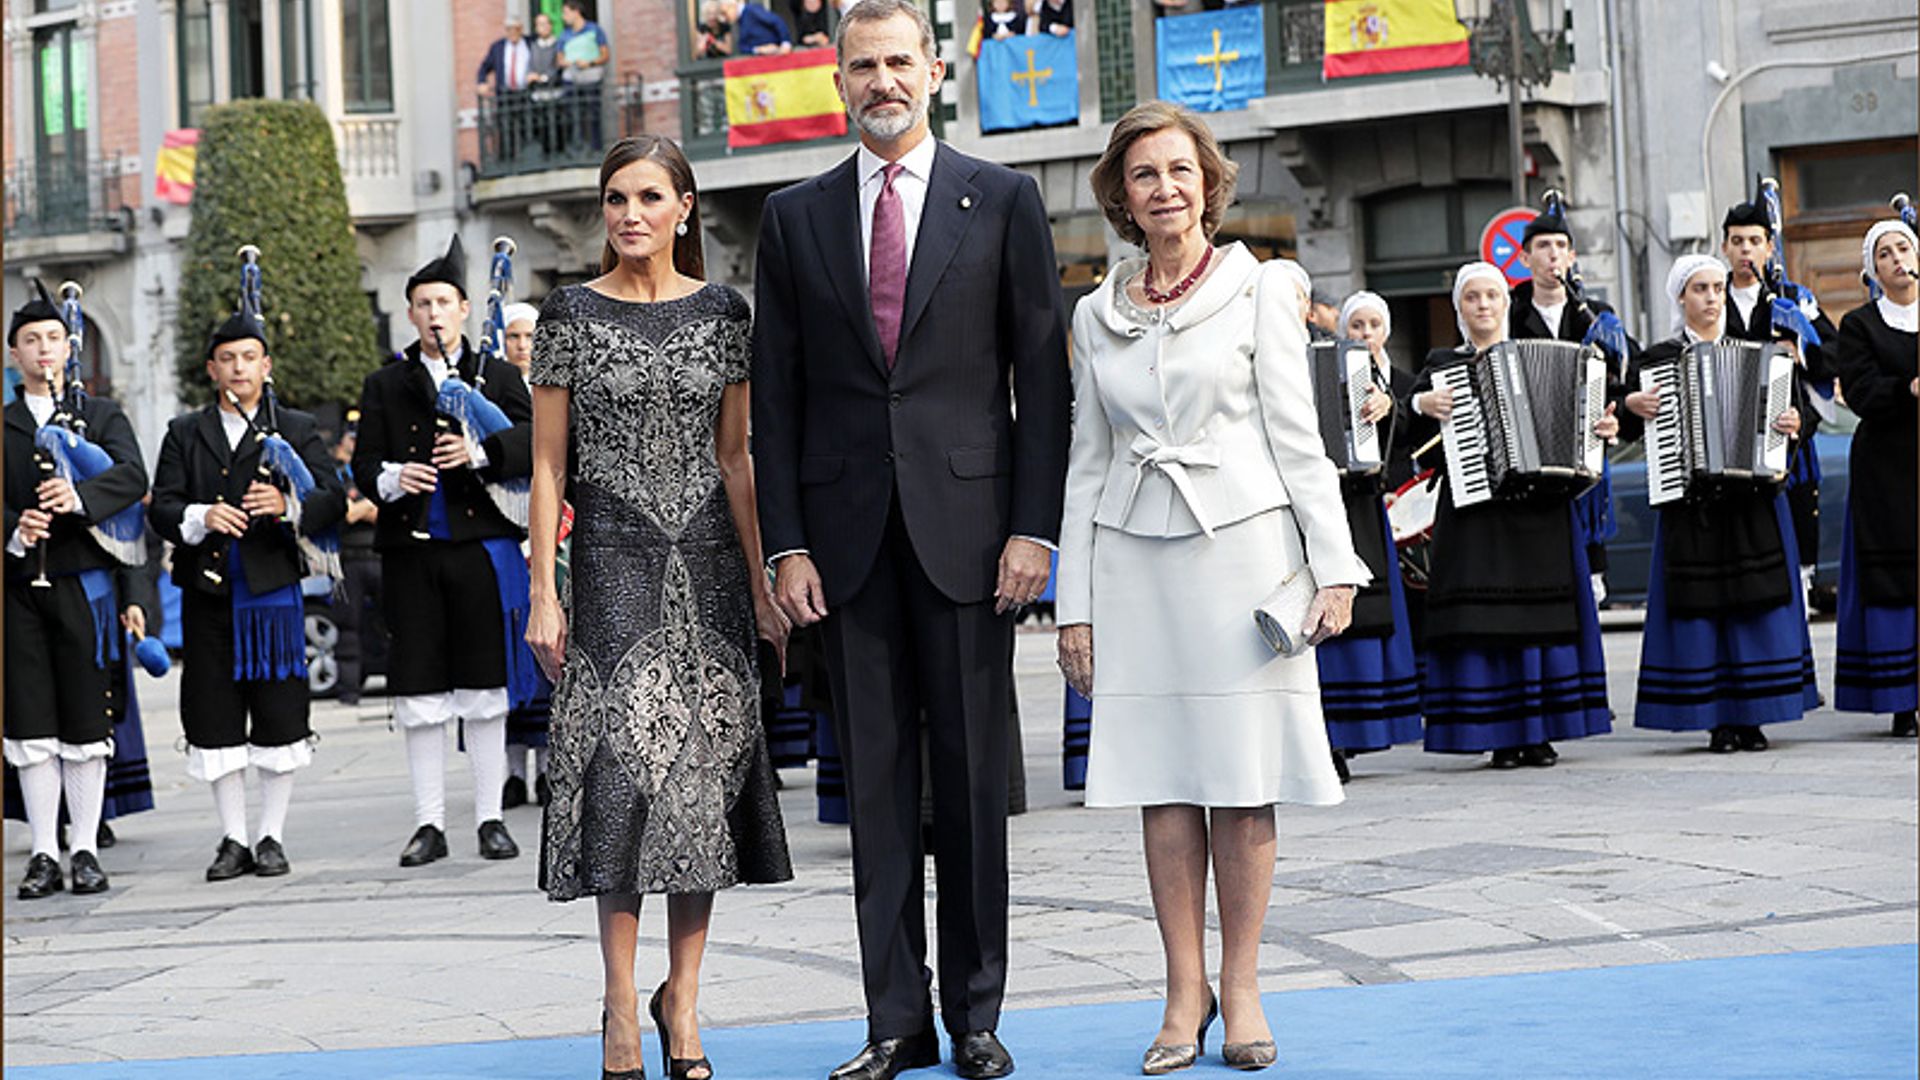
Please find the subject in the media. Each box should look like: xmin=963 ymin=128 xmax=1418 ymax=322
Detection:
xmin=6 ymin=945 xmax=1920 ymax=1080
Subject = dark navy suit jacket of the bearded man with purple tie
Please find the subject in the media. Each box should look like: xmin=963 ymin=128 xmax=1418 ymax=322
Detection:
xmin=753 ymin=144 xmax=1071 ymax=605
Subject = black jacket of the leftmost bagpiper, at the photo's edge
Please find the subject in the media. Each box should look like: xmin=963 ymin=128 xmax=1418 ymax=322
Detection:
xmin=0 ymin=396 xmax=146 ymax=578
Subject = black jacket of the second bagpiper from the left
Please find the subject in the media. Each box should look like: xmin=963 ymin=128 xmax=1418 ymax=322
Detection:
xmin=152 ymin=405 xmax=348 ymax=596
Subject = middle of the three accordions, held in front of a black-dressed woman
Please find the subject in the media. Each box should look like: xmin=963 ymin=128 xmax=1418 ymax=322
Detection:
xmin=1434 ymin=340 xmax=1607 ymax=505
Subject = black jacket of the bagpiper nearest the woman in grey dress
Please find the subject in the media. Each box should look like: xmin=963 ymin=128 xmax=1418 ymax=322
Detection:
xmin=353 ymin=336 xmax=534 ymax=552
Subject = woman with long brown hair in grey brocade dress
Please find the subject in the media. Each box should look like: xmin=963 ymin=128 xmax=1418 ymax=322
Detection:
xmin=526 ymin=136 xmax=793 ymax=1078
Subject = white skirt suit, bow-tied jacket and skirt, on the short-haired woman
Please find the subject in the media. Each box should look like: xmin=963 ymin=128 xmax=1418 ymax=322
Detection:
xmin=1056 ymin=244 xmax=1371 ymax=807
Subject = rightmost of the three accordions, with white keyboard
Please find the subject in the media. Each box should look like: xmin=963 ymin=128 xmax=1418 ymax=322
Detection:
xmin=1640 ymin=338 xmax=1793 ymax=505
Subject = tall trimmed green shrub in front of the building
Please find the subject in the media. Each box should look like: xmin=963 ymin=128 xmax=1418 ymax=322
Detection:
xmin=175 ymin=100 xmax=382 ymax=409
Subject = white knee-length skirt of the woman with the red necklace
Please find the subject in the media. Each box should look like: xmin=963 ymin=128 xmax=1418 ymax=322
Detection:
xmin=1087 ymin=507 xmax=1346 ymax=807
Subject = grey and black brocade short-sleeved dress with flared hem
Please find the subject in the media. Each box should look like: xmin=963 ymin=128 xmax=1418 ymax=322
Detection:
xmin=532 ymin=284 xmax=793 ymax=899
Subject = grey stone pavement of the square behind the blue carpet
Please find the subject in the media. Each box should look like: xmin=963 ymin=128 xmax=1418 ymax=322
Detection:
xmin=4 ymin=623 xmax=1920 ymax=1065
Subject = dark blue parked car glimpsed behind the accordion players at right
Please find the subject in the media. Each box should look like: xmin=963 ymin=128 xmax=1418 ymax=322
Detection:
xmin=1607 ymin=409 xmax=1859 ymax=613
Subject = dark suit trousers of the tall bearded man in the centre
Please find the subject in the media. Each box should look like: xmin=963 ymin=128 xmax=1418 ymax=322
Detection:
xmin=822 ymin=498 xmax=1014 ymax=1040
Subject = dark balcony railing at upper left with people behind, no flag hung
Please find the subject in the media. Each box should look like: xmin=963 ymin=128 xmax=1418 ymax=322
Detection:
xmin=480 ymin=71 xmax=647 ymax=179
